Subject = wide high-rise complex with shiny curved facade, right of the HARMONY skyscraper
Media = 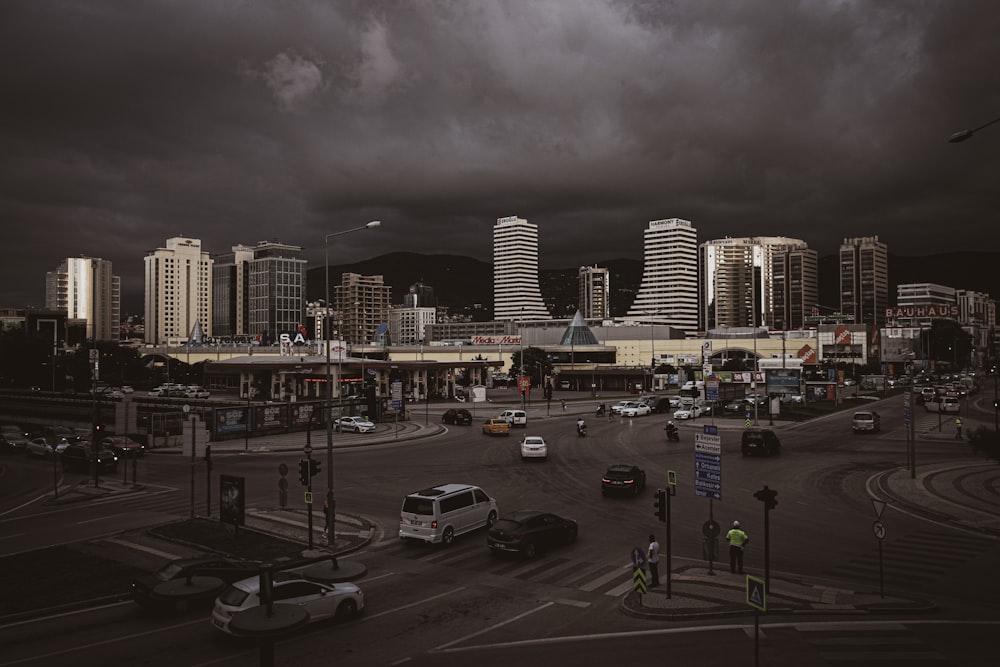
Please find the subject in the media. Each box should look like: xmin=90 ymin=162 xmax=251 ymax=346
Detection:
xmin=700 ymin=236 xmax=818 ymax=331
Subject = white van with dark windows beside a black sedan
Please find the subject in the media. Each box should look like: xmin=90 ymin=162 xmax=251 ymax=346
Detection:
xmin=399 ymin=484 xmax=497 ymax=544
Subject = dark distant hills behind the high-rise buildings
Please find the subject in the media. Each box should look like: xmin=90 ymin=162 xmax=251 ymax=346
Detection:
xmin=307 ymin=252 xmax=1000 ymax=320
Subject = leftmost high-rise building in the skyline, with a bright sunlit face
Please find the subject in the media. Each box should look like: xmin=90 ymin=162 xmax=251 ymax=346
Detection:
xmin=45 ymin=257 xmax=121 ymax=340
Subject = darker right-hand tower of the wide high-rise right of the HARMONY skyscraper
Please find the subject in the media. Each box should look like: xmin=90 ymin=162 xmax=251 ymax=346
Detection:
xmin=769 ymin=247 xmax=819 ymax=331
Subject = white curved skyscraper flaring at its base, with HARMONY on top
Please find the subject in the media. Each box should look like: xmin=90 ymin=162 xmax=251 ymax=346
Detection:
xmin=627 ymin=218 xmax=698 ymax=335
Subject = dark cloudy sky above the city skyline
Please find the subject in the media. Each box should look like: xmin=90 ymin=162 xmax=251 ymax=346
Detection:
xmin=0 ymin=0 xmax=1000 ymax=314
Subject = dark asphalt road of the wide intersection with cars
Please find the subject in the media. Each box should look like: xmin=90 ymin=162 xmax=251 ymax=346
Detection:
xmin=0 ymin=398 xmax=1000 ymax=665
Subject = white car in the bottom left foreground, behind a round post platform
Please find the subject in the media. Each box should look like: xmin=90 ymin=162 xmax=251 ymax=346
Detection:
xmin=212 ymin=572 xmax=365 ymax=635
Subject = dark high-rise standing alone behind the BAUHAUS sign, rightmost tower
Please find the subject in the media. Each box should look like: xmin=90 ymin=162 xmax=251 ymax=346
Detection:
xmin=840 ymin=236 xmax=889 ymax=330
